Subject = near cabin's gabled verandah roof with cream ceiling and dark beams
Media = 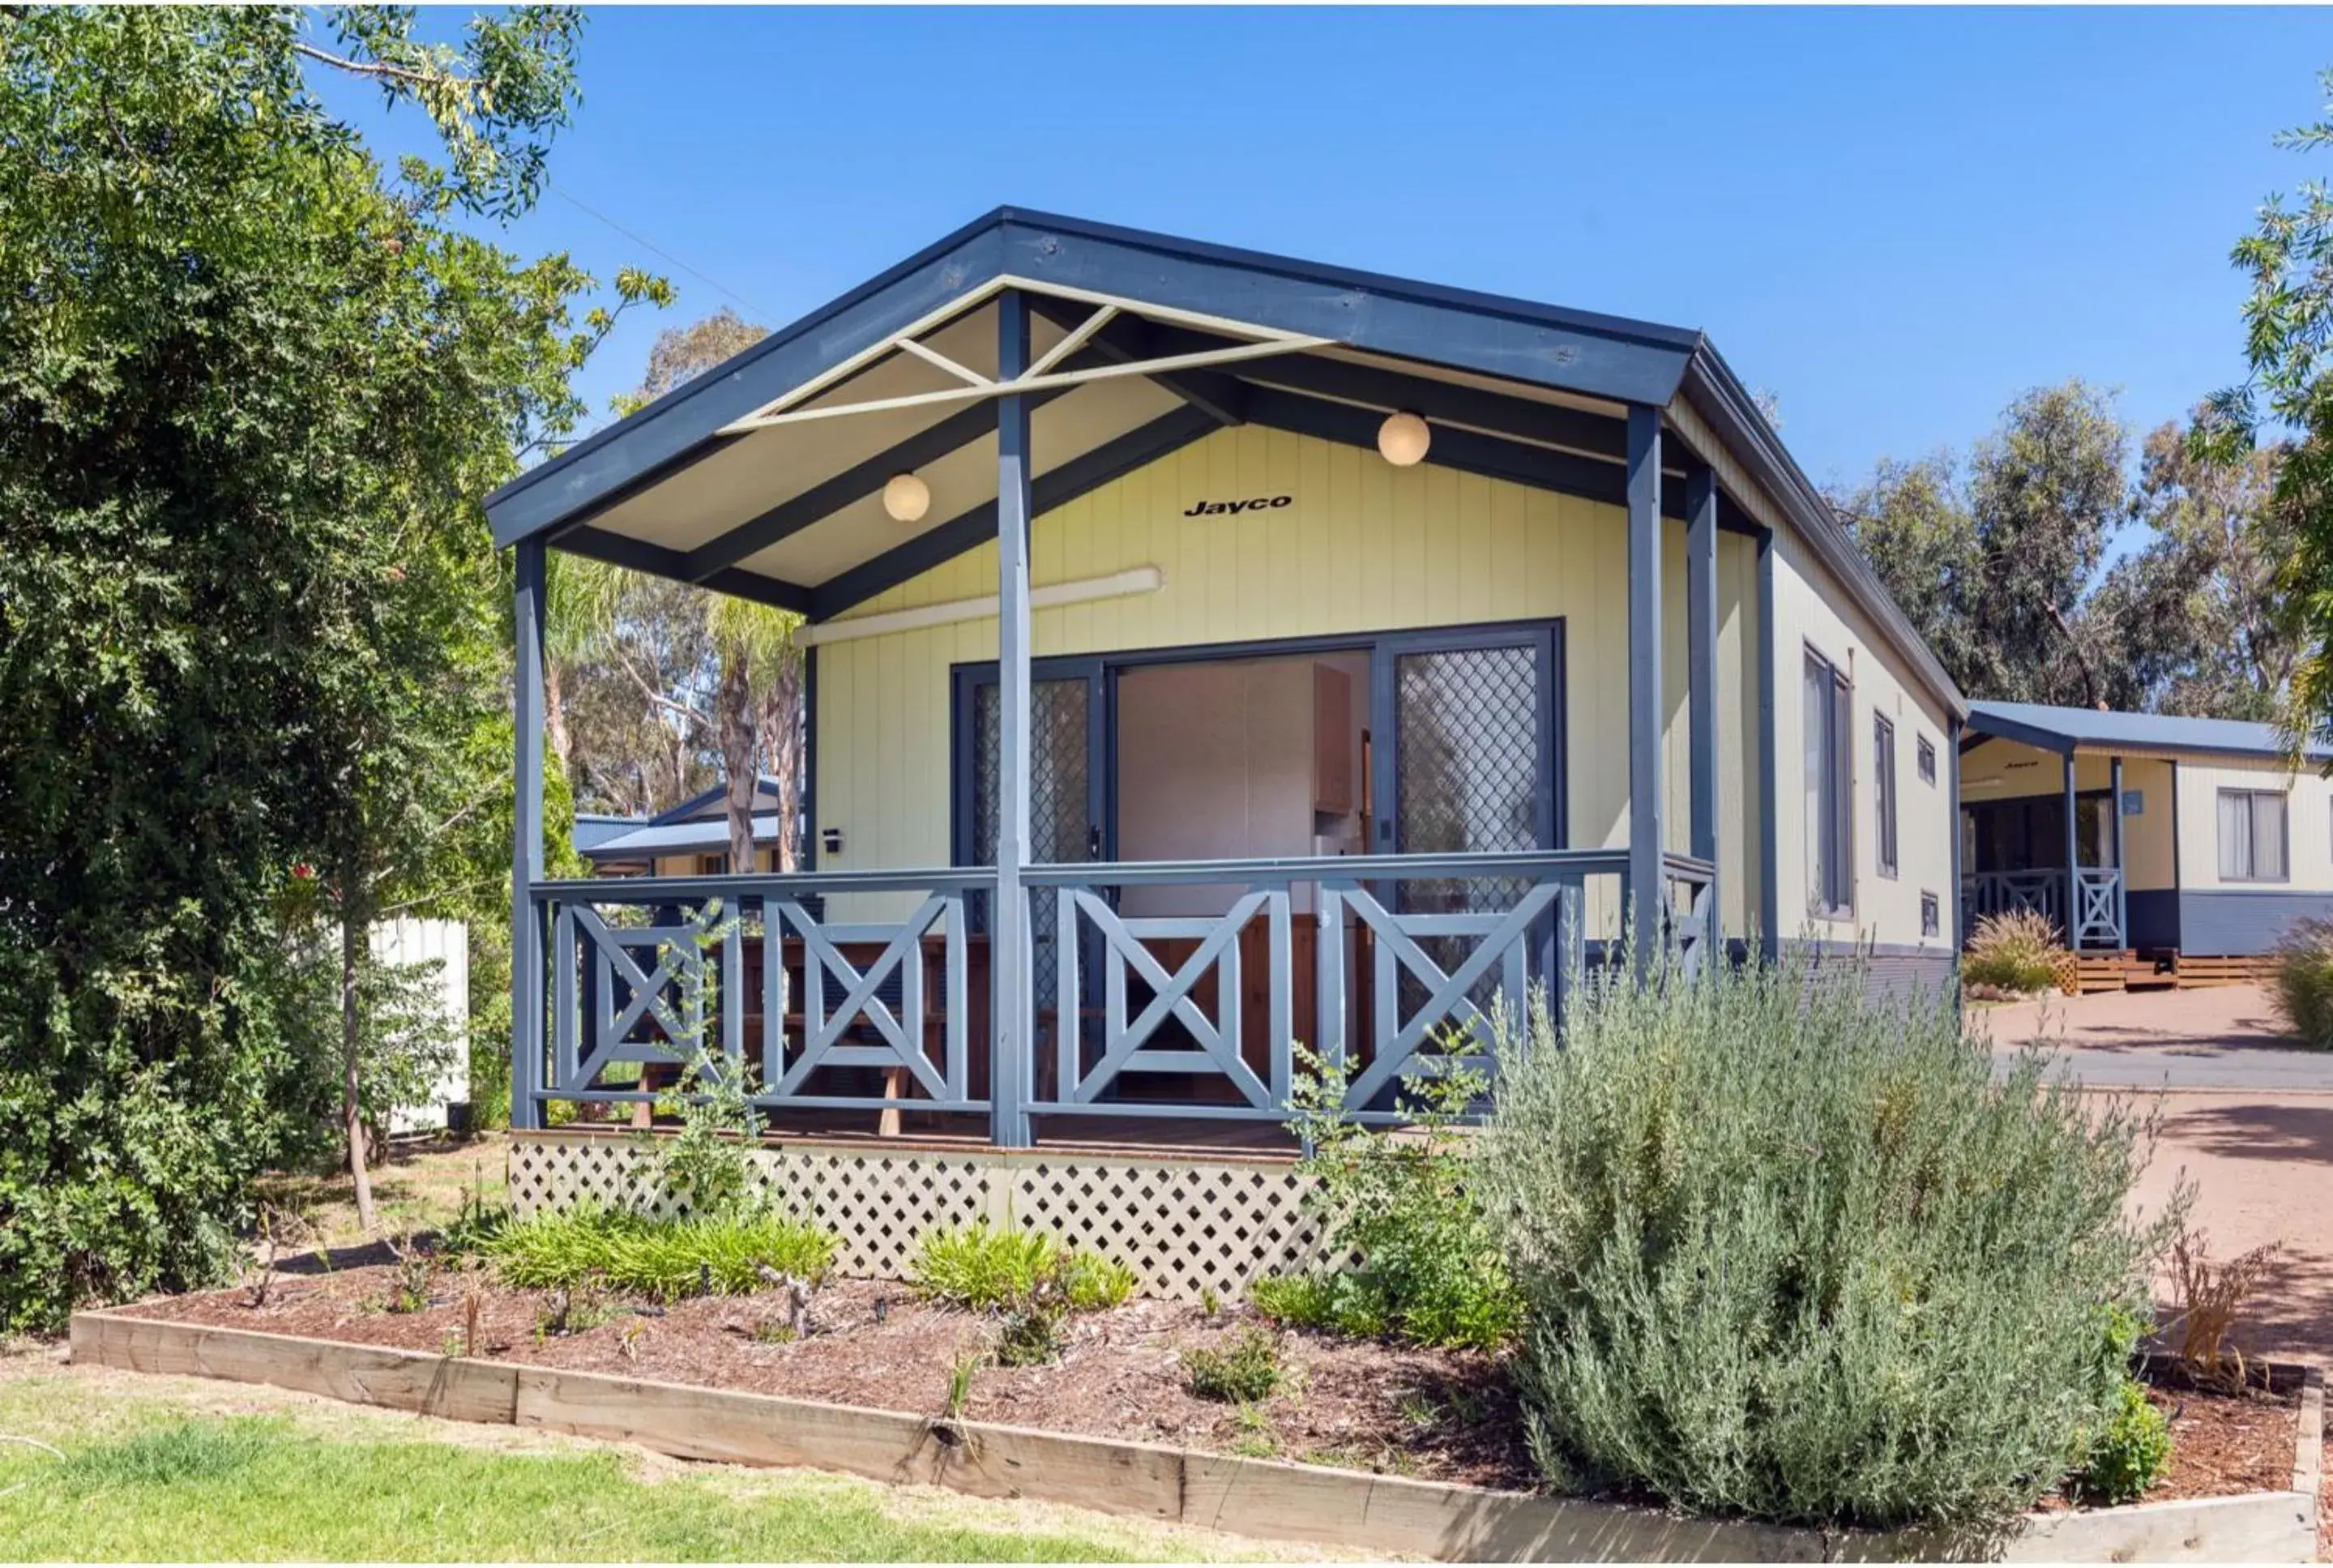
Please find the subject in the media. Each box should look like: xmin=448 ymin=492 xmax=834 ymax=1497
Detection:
xmin=488 ymin=207 xmax=1962 ymax=711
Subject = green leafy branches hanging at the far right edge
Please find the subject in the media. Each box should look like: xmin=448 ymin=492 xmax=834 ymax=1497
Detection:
xmin=2195 ymin=70 xmax=2333 ymax=749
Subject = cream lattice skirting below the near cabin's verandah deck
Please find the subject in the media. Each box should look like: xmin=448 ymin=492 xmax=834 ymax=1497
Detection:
xmin=511 ymin=1132 xmax=1322 ymax=1302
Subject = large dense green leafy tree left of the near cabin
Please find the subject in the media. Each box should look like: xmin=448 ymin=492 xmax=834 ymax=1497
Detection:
xmin=0 ymin=7 xmax=663 ymax=1327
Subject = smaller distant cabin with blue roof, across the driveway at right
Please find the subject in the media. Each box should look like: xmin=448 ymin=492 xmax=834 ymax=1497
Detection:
xmin=1959 ymin=703 xmax=2333 ymax=980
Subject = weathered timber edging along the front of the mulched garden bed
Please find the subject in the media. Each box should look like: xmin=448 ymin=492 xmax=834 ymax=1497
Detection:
xmin=72 ymin=1309 xmax=2323 ymax=1563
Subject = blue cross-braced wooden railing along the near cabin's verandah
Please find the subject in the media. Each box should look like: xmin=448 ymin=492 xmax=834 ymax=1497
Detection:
xmin=513 ymin=849 xmax=1715 ymax=1120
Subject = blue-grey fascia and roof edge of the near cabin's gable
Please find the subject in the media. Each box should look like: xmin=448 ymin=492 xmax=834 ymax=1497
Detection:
xmin=485 ymin=207 xmax=1967 ymax=716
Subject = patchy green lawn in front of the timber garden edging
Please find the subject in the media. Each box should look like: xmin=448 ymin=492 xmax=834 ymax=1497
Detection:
xmin=0 ymin=1351 xmax=1271 ymax=1561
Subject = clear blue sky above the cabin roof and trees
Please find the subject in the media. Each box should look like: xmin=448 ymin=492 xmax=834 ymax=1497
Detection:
xmin=345 ymin=10 xmax=2333 ymax=497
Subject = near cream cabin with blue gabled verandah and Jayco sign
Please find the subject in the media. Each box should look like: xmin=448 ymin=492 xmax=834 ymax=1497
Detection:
xmin=488 ymin=210 xmax=1964 ymax=1148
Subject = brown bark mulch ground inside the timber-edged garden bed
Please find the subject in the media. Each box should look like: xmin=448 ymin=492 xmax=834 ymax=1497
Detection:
xmin=135 ymin=1265 xmax=2298 ymax=1502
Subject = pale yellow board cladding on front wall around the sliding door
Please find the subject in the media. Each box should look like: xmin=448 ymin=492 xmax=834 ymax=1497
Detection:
xmin=817 ymin=427 xmax=1754 ymax=934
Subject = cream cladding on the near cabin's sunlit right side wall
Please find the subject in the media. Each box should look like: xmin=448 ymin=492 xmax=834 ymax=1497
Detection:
xmin=1773 ymin=528 xmax=1967 ymax=955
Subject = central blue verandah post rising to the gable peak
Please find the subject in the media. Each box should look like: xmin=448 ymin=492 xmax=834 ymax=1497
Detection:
xmin=989 ymin=289 xmax=1036 ymax=1148
